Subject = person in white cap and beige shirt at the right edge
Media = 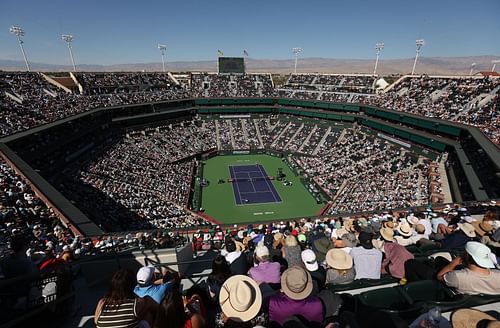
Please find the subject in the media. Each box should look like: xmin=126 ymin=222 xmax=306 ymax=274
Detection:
xmin=437 ymin=241 xmax=500 ymax=295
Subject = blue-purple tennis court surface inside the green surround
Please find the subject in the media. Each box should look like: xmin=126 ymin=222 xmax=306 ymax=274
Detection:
xmin=229 ymin=164 xmax=281 ymax=205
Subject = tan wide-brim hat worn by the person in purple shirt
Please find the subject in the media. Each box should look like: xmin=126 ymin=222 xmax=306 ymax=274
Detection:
xmin=281 ymin=266 xmax=313 ymax=301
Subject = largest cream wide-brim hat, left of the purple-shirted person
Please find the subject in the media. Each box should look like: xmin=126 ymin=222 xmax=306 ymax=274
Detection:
xmin=219 ymin=275 xmax=262 ymax=322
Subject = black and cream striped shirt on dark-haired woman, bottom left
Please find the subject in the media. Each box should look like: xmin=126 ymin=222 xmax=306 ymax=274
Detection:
xmin=96 ymin=299 xmax=139 ymax=328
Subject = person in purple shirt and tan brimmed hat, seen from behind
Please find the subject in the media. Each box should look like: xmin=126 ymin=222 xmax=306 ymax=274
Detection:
xmin=268 ymin=267 xmax=324 ymax=325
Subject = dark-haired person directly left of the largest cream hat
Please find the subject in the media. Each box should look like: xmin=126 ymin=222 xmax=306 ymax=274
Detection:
xmin=154 ymin=289 xmax=206 ymax=328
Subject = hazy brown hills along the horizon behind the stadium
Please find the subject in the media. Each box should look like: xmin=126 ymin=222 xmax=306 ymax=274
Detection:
xmin=0 ymin=56 xmax=500 ymax=75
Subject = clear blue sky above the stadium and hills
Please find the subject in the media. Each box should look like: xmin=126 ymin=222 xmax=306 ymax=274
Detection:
xmin=0 ymin=0 xmax=500 ymax=64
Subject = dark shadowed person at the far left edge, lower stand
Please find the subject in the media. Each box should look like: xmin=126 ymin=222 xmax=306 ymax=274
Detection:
xmin=0 ymin=235 xmax=39 ymax=279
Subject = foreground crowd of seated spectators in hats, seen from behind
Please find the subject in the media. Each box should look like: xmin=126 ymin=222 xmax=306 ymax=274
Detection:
xmin=94 ymin=202 xmax=500 ymax=328
